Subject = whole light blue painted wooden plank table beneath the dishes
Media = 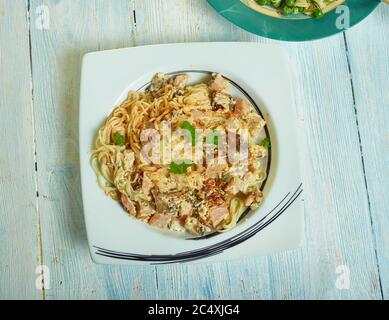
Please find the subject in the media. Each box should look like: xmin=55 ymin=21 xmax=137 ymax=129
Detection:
xmin=0 ymin=0 xmax=389 ymax=299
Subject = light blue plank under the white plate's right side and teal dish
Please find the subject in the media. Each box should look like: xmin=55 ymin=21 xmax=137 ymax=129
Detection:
xmin=135 ymin=0 xmax=381 ymax=299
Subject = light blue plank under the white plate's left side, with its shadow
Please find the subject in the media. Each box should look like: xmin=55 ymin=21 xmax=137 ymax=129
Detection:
xmin=31 ymin=0 xmax=156 ymax=299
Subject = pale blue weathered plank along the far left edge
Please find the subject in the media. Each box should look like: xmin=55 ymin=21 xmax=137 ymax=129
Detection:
xmin=0 ymin=0 xmax=41 ymax=299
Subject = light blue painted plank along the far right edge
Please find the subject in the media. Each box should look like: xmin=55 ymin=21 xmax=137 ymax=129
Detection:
xmin=346 ymin=5 xmax=389 ymax=299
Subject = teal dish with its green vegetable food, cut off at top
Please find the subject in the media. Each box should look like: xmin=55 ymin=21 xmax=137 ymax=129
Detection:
xmin=208 ymin=0 xmax=380 ymax=41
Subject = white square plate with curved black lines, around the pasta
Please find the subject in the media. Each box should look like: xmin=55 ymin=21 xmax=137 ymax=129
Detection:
xmin=80 ymin=42 xmax=304 ymax=264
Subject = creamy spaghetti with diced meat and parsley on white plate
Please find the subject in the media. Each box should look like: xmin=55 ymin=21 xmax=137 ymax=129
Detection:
xmin=91 ymin=73 xmax=270 ymax=236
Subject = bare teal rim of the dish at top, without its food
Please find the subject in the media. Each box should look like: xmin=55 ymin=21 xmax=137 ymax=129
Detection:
xmin=208 ymin=0 xmax=380 ymax=41
